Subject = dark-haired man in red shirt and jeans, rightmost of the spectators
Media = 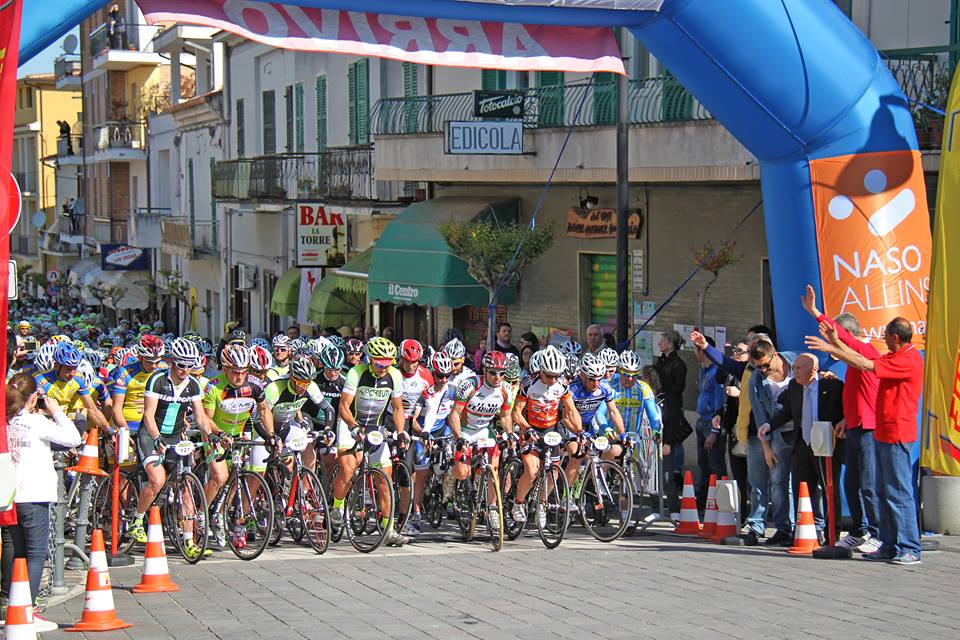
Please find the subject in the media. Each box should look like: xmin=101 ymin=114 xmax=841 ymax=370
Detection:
xmin=807 ymin=318 xmax=923 ymax=565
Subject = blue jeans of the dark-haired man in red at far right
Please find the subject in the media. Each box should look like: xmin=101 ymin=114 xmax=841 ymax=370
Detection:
xmin=876 ymin=442 xmax=920 ymax=557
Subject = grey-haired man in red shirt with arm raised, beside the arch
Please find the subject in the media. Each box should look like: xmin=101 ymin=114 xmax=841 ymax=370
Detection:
xmin=800 ymin=285 xmax=880 ymax=553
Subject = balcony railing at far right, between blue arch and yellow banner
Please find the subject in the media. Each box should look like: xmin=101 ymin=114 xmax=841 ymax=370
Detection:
xmin=880 ymin=46 xmax=960 ymax=149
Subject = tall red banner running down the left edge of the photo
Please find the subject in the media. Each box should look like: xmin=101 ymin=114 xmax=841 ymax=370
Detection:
xmin=0 ymin=0 xmax=23 ymax=525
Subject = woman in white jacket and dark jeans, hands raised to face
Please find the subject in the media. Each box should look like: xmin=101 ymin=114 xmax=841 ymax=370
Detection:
xmin=0 ymin=374 xmax=81 ymax=616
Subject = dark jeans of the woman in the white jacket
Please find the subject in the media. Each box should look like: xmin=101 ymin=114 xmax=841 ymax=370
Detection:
xmin=0 ymin=502 xmax=50 ymax=603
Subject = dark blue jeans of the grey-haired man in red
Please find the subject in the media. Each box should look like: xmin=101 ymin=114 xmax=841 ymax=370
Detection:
xmin=843 ymin=427 xmax=880 ymax=537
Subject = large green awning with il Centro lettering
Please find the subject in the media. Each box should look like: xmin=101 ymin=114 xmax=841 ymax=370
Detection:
xmin=367 ymin=197 xmax=520 ymax=308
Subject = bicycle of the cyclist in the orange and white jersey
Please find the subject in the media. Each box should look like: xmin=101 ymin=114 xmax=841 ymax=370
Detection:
xmin=503 ymin=431 xmax=570 ymax=549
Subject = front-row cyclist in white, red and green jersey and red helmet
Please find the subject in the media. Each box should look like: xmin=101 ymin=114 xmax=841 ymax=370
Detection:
xmin=447 ymin=351 xmax=513 ymax=530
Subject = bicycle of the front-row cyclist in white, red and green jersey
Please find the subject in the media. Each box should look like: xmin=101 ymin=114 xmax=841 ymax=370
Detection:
xmin=453 ymin=438 xmax=503 ymax=551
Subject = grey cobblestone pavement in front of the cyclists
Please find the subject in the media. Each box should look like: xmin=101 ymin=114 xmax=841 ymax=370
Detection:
xmin=43 ymin=527 xmax=960 ymax=640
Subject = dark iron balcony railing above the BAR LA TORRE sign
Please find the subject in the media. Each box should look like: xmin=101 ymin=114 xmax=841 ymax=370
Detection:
xmin=213 ymin=145 xmax=402 ymax=202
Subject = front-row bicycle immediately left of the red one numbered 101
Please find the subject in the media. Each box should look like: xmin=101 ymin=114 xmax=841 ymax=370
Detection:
xmin=210 ymin=440 xmax=274 ymax=560
